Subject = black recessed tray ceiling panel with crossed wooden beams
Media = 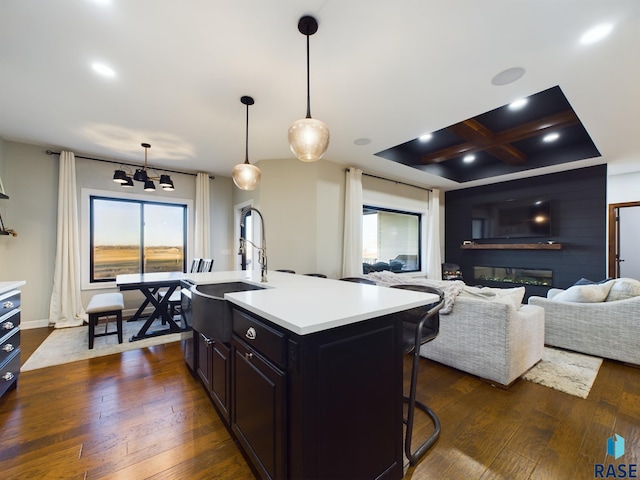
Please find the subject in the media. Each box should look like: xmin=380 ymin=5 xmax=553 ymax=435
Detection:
xmin=376 ymin=86 xmax=600 ymax=183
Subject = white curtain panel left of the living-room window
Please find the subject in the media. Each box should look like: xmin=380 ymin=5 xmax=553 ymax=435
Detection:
xmin=342 ymin=167 xmax=362 ymax=277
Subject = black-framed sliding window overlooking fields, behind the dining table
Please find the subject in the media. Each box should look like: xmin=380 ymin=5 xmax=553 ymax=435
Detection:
xmin=89 ymin=195 xmax=187 ymax=282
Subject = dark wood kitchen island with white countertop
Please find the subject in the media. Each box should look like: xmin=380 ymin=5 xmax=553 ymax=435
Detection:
xmin=183 ymin=271 xmax=437 ymax=479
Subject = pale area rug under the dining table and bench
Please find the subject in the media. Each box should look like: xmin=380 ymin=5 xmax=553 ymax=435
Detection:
xmin=20 ymin=320 xmax=186 ymax=372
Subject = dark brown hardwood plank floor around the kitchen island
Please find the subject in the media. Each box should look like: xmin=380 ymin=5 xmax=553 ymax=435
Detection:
xmin=0 ymin=329 xmax=640 ymax=480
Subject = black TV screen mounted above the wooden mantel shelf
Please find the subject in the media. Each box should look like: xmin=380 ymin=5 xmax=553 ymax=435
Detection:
xmin=471 ymin=198 xmax=551 ymax=240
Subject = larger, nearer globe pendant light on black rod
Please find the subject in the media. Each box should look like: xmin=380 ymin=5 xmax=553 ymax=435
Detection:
xmin=289 ymin=16 xmax=329 ymax=162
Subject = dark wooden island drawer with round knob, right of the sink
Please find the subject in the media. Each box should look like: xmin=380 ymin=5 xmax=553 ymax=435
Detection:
xmin=233 ymin=308 xmax=286 ymax=368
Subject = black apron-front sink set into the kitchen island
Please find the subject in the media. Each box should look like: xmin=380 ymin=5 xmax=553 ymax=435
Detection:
xmin=191 ymin=282 xmax=264 ymax=342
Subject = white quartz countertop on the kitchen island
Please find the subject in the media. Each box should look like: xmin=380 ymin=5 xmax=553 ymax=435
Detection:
xmin=184 ymin=270 xmax=438 ymax=335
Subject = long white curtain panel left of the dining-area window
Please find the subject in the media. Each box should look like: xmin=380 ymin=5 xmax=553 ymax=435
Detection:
xmin=49 ymin=151 xmax=87 ymax=328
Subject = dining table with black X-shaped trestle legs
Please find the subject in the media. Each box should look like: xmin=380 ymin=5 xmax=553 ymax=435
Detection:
xmin=116 ymin=272 xmax=190 ymax=342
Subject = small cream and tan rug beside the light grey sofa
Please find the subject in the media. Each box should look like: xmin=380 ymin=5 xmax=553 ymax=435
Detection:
xmin=522 ymin=347 xmax=602 ymax=398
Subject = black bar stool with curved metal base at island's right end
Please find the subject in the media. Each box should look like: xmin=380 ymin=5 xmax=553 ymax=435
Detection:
xmin=391 ymin=284 xmax=444 ymax=465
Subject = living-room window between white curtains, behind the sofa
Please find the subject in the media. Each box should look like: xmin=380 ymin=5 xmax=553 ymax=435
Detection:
xmin=362 ymin=206 xmax=422 ymax=273
